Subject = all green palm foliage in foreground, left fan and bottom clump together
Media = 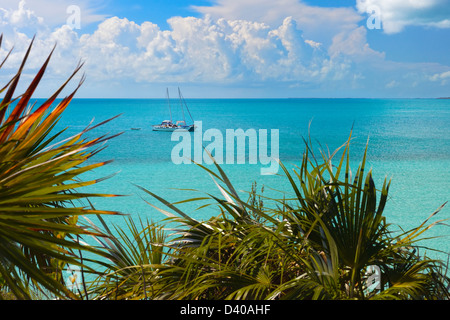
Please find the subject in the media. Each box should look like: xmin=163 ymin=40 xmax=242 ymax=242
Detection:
xmin=0 ymin=38 xmax=450 ymax=300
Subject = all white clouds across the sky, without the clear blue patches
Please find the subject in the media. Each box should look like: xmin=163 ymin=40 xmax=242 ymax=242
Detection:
xmin=0 ymin=0 xmax=450 ymax=97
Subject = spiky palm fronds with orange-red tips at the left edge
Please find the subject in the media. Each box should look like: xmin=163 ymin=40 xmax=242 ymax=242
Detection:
xmin=0 ymin=36 xmax=119 ymax=299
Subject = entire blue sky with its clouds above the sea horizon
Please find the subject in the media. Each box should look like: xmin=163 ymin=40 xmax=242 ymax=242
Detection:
xmin=0 ymin=0 xmax=450 ymax=98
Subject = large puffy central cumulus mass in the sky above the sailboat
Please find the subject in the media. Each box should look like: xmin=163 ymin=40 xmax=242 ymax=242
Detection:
xmin=75 ymin=16 xmax=330 ymax=83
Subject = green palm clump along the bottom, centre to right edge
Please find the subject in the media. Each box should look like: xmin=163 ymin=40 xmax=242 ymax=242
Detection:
xmin=95 ymin=132 xmax=449 ymax=300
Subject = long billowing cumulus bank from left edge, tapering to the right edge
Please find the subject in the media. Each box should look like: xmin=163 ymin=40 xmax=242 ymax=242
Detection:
xmin=0 ymin=0 xmax=448 ymax=97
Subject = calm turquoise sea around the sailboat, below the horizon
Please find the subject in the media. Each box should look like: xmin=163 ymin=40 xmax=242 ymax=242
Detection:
xmin=58 ymin=99 xmax=450 ymax=260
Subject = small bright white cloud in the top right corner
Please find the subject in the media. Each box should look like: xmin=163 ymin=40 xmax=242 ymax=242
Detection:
xmin=356 ymin=0 xmax=450 ymax=33
